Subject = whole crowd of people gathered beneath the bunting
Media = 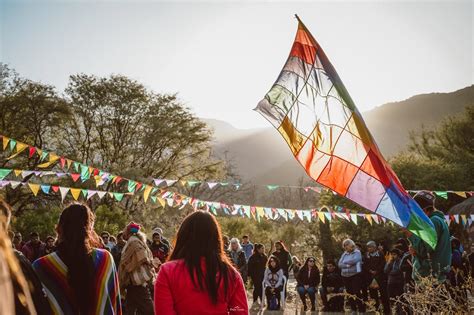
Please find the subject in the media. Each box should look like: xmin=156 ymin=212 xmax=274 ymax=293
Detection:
xmin=0 ymin=192 xmax=474 ymax=314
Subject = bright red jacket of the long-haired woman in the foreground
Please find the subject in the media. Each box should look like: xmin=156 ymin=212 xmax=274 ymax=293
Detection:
xmin=155 ymin=260 xmax=248 ymax=315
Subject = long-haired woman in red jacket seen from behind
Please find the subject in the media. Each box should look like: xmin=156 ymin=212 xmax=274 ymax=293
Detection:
xmin=155 ymin=211 xmax=248 ymax=315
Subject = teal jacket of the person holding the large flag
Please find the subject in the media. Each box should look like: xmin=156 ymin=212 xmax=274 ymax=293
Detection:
xmin=409 ymin=210 xmax=451 ymax=283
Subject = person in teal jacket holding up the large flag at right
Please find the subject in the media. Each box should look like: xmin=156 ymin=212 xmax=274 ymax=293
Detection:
xmin=409 ymin=191 xmax=451 ymax=284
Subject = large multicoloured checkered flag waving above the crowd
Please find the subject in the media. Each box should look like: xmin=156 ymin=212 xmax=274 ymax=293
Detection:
xmin=255 ymin=18 xmax=437 ymax=248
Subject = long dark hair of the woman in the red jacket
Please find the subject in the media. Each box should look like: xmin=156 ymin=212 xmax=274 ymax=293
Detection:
xmin=169 ymin=211 xmax=235 ymax=304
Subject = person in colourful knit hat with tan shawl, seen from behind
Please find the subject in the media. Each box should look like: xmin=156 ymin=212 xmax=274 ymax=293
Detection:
xmin=119 ymin=222 xmax=156 ymax=315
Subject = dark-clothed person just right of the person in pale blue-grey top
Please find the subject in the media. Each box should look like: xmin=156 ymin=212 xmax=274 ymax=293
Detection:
xmin=365 ymin=241 xmax=390 ymax=314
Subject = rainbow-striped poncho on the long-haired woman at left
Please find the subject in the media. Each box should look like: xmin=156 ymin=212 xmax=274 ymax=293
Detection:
xmin=33 ymin=248 xmax=122 ymax=315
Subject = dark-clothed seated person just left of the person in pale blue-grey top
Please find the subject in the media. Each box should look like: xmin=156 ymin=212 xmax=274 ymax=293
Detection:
xmin=319 ymin=260 xmax=344 ymax=312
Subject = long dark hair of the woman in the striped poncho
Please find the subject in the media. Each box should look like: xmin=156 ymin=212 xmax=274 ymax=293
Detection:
xmin=57 ymin=204 xmax=100 ymax=314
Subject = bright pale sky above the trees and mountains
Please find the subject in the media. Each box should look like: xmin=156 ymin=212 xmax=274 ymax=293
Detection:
xmin=0 ymin=0 xmax=474 ymax=128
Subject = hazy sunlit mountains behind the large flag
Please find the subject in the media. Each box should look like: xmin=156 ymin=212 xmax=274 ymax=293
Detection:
xmin=205 ymin=86 xmax=474 ymax=185
